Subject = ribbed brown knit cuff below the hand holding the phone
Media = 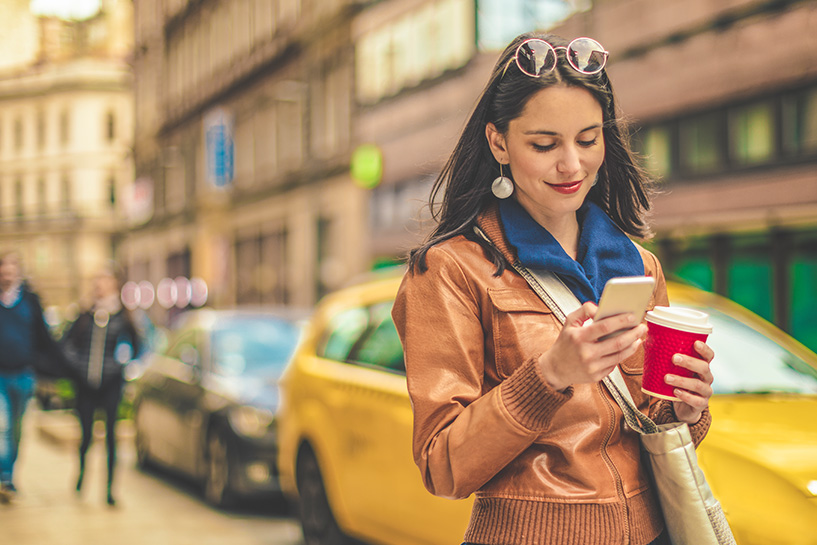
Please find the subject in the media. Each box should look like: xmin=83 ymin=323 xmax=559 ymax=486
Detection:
xmin=500 ymin=357 xmax=573 ymax=430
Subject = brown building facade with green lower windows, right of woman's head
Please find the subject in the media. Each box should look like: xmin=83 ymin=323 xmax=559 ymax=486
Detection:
xmin=555 ymin=0 xmax=817 ymax=349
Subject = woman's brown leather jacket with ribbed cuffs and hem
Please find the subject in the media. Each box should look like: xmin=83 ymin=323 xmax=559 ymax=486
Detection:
xmin=393 ymin=206 xmax=710 ymax=545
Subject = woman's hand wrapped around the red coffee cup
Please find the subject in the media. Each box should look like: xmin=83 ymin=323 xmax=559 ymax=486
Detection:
xmin=664 ymin=341 xmax=715 ymax=424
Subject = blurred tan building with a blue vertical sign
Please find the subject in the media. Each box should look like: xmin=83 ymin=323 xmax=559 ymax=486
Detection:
xmin=124 ymin=0 xmax=368 ymax=318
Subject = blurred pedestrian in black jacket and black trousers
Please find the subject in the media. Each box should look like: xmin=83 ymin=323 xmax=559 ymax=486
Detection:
xmin=63 ymin=263 xmax=140 ymax=505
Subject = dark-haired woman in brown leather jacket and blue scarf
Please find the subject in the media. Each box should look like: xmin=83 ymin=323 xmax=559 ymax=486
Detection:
xmin=393 ymin=34 xmax=713 ymax=545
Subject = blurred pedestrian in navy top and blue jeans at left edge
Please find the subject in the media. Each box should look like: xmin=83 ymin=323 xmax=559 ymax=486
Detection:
xmin=0 ymin=252 xmax=68 ymax=502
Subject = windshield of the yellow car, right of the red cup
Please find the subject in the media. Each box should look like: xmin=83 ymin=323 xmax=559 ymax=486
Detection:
xmin=685 ymin=305 xmax=817 ymax=394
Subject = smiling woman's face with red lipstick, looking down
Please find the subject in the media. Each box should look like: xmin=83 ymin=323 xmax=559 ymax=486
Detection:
xmin=486 ymin=85 xmax=604 ymax=225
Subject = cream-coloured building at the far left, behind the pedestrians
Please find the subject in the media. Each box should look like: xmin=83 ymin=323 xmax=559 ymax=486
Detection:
xmin=0 ymin=0 xmax=133 ymax=308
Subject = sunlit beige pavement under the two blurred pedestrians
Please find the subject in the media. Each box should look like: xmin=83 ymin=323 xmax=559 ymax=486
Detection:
xmin=0 ymin=404 xmax=303 ymax=545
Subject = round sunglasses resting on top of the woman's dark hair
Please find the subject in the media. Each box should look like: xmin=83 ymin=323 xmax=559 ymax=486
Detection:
xmin=502 ymin=37 xmax=609 ymax=78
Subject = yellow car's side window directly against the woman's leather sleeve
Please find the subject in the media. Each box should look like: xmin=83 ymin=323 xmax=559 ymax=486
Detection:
xmin=350 ymin=302 xmax=406 ymax=372
